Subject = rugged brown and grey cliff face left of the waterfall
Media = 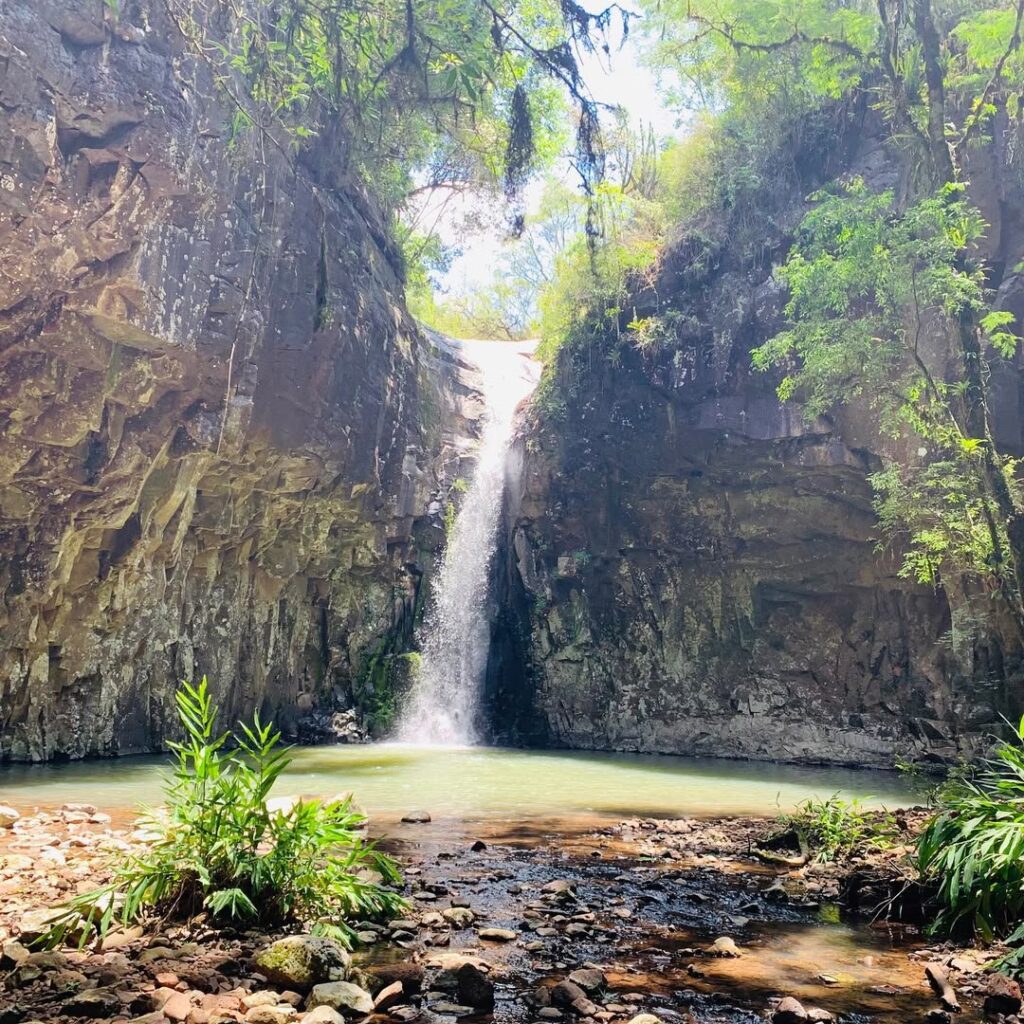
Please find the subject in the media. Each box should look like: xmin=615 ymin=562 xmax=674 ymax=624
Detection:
xmin=0 ymin=0 xmax=473 ymax=759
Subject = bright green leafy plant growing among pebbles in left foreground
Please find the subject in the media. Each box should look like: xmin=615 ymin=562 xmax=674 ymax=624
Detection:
xmin=43 ymin=677 xmax=404 ymax=946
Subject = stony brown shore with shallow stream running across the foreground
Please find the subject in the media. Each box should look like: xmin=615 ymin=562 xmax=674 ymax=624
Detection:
xmin=0 ymin=804 xmax=1020 ymax=1024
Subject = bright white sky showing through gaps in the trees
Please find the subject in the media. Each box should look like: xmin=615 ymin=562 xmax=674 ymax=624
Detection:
xmin=422 ymin=5 xmax=680 ymax=295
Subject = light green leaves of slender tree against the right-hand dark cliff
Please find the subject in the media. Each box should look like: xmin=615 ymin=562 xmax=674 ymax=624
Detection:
xmin=753 ymin=180 xmax=1017 ymax=589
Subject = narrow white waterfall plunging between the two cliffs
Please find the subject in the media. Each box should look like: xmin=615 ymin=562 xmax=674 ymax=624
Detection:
xmin=396 ymin=341 xmax=538 ymax=746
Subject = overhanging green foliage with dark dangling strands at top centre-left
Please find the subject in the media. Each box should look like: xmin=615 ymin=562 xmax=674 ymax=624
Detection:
xmin=168 ymin=0 xmax=629 ymax=216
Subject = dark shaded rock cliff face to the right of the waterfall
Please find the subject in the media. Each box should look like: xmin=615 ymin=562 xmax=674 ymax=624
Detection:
xmin=500 ymin=116 xmax=1024 ymax=765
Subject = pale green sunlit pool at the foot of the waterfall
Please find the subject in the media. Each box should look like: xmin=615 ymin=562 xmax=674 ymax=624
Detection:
xmin=0 ymin=743 xmax=929 ymax=820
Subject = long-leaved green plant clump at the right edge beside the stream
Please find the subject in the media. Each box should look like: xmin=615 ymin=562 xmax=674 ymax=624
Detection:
xmin=918 ymin=719 xmax=1024 ymax=969
